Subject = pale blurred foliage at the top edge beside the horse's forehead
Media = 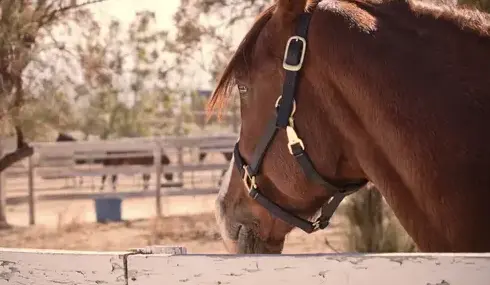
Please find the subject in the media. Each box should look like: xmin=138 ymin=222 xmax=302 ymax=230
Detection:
xmin=174 ymin=0 xmax=273 ymax=85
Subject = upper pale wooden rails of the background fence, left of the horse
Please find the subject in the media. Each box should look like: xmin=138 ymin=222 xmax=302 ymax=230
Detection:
xmin=6 ymin=134 xmax=237 ymax=186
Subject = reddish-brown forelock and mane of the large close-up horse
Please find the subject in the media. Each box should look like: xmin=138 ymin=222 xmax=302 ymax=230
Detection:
xmin=207 ymin=0 xmax=490 ymax=118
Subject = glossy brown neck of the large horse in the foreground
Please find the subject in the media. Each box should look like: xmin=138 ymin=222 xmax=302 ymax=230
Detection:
xmin=305 ymin=1 xmax=490 ymax=251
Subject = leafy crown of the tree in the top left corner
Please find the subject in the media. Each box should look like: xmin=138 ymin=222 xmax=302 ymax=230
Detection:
xmin=0 ymin=0 xmax=103 ymax=121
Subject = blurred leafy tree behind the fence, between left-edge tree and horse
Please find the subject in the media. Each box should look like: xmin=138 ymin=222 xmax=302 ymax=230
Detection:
xmin=77 ymin=11 xmax=183 ymax=139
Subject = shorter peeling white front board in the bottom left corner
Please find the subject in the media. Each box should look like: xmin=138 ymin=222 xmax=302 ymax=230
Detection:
xmin=0 ymin=248 xmax=130 ymax=285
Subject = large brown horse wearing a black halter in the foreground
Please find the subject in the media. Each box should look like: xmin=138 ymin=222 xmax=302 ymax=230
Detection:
xmin=209 ymin=0 xmax=490 ymax=253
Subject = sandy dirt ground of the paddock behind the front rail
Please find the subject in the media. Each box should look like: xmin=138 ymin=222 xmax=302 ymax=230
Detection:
xmin=0 ymin=195 xmax=340 ymax=253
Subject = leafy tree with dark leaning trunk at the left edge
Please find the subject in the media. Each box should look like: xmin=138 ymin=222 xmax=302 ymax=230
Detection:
xmin=0 ymin=0 xmax=103 ymax=226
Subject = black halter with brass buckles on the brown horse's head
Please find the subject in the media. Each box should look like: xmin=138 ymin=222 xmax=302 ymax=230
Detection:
xmin=234 ymin=13 xmax=368 ymax=233
